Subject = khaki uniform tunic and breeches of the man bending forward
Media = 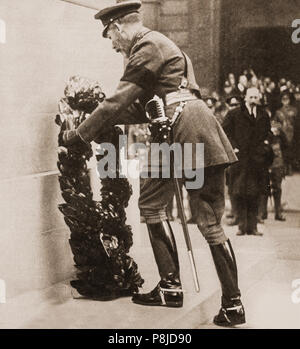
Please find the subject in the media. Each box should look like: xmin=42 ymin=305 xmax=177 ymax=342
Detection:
xmin=78 ymin=27 xmax=237 ymax=244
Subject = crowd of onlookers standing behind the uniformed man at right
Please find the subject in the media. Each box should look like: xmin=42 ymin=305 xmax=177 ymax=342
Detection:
xmin=204 ymin=69 xmax=300 ymax=235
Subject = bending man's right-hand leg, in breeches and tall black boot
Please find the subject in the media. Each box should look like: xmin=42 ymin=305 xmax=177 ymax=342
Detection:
xmin=189 ymin=167 xmax=245 ymax=326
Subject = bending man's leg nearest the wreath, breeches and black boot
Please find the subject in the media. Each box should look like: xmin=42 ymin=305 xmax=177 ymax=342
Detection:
xmin=133 ymin=178 xmax=183 ymax=307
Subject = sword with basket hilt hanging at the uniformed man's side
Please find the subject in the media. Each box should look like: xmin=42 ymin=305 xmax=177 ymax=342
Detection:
xmin=145 ymin=98 xmax=200 ymax=292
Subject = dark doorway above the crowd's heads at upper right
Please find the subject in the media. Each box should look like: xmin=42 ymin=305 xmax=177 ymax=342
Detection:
xmin=219 ymin=0 xmax=300 ymax=89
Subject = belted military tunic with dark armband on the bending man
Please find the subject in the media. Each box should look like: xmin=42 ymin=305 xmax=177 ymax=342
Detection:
xmin=78 ymin=28 xmax=236 ymax=167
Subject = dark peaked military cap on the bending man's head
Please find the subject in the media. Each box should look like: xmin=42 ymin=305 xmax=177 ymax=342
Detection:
xmin=95 ymin=0 xmax=142 ymax=37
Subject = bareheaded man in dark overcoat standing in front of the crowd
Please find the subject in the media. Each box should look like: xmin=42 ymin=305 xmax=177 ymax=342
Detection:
xmin=222 ymin=87 xmax=273 ymax=235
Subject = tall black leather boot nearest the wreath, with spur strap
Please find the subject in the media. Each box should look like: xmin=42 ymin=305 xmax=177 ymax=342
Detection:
xmin=132 ymin=221 xmax=183 ymax=307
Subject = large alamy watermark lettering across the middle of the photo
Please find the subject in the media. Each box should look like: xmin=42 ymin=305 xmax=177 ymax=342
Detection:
xmin=97 ymin=135 xmax=204 ymax=189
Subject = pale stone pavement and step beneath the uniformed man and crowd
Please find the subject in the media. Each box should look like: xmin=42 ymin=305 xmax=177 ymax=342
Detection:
xmin=0 ymin=175 xmax=300 ymax=329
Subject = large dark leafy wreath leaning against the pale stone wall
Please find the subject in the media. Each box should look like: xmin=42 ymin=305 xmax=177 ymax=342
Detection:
xmin=56 ymin=76 xmax=144 ymax=300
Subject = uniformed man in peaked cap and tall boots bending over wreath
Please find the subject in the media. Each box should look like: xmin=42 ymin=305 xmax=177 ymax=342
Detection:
xmin=59 ymin=0 xmax=245 ymax=326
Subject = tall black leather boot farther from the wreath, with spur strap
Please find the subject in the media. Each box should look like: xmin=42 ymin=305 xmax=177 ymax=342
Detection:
xmin=210 ymin=240 xmax=245 ymax=326
